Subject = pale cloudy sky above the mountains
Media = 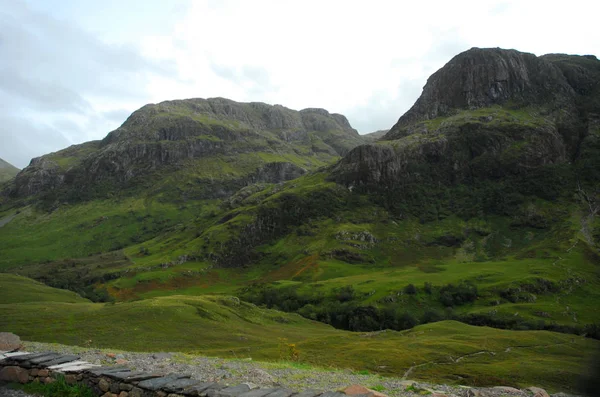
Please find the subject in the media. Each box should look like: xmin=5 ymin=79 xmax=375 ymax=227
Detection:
xmin=0 ymin=0 xmax=600 ymax=168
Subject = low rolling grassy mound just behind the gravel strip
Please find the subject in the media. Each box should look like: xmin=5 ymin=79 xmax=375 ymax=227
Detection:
xmin=0 ymin=275 xmax=600 ymax=392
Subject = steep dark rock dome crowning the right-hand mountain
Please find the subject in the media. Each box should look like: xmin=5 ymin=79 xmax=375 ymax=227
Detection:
xmin=392 ymin=48 xmax=574 ymax=132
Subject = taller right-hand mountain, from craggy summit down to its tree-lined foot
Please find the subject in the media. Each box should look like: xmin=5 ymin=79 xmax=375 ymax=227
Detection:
xmin=156 ymin=49 xmax=600 ymax=337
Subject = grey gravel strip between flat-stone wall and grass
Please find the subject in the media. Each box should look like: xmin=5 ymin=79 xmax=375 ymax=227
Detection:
xmin=18 ymin=342 xmax=566 ymax=397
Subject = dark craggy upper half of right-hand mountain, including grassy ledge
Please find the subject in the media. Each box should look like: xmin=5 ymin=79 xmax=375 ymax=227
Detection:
xmin=332 ymin=48 xmax=600 ymax=186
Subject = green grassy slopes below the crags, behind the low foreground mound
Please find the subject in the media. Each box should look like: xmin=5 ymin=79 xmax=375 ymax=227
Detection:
xmin=0 ymin=152 xmax=600 ymax=334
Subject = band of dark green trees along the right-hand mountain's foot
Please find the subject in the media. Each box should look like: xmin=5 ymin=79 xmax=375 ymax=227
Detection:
xmin=240 ymin=279 xmax=600 ymax=339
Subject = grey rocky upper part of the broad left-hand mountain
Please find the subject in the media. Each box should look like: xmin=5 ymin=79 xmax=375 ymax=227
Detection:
xmin=9 ymin=98 xmax=363 ymax=197
